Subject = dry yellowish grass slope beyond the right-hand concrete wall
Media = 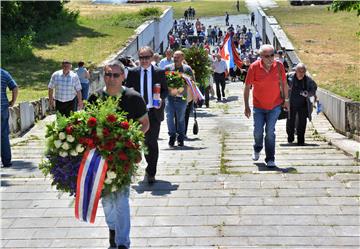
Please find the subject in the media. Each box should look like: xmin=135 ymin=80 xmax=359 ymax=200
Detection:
xmin=266 ymin=1 xmax=360 ymax=101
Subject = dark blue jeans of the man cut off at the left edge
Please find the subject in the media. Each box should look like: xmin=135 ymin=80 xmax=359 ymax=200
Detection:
xmin=1 ymin=106 xmax=11 ymax=166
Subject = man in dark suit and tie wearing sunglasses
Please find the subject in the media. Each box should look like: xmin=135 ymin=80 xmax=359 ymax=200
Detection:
xmin=126 ymin=47 xmax=168 ymax=184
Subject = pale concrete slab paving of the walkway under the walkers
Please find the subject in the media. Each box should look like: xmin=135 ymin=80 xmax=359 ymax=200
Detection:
xmin=1 ymin=82 xmax=360 ymax=248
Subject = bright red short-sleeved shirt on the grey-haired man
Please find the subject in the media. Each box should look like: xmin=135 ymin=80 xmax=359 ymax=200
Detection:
xmin=245 ymin=60 xmax=286 ymax=110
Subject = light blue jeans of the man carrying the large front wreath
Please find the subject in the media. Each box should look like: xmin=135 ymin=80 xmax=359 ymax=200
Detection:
xmin=102 ymin=187 xmax=130 ymax=248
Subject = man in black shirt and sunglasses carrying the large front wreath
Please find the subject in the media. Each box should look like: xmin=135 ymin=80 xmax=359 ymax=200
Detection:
xmin=89 ymin=64 xmax=150 ymax=249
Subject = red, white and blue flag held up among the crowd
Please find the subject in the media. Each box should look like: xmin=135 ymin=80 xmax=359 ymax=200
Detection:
xmin=220 ymin=32 xmax=242 ymax=69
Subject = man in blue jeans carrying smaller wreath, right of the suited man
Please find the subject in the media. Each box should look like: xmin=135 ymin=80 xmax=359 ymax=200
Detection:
xmin=165 ymin=51 xmax=193 ymax=147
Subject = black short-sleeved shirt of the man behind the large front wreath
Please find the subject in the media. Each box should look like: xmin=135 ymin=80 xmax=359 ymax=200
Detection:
xmin=88 ymin=87 xmax=147 ymax=120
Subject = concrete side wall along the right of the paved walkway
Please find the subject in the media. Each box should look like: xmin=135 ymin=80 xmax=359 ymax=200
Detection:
xmin=255 ymin=8 xmax=360 ymax=141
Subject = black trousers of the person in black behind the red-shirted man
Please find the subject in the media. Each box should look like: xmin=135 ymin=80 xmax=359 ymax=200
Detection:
xmin=286 ymin=106 xmax=308 ymax=144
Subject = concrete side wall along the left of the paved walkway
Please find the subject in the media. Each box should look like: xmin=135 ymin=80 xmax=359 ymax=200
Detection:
xmin=9 ymin=8 xmax=173 ymax=135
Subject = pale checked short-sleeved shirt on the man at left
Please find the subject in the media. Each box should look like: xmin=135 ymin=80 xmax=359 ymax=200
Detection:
xmin=48 ymin=70 xmax=81 ymax=102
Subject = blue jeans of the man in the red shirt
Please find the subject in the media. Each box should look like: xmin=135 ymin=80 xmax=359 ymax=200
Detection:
xmin=254 ymin=106 xmax=281 ymax=162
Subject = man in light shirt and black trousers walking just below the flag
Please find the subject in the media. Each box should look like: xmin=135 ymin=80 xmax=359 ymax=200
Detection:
xmin=213 ymin=54 xmax=229 ymax=101
